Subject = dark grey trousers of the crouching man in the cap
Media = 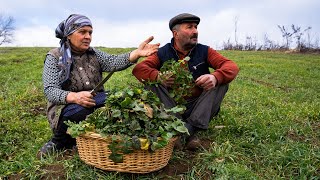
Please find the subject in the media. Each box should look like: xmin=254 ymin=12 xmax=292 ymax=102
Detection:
xmin=146 ymin=84 xmax=229 ymax=129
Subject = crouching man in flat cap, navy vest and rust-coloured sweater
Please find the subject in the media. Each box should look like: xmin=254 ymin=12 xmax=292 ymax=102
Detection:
xmin=132 ymin=13 xmax=239 ymax=150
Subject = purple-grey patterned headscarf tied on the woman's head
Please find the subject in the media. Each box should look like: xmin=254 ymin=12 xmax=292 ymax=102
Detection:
xmin=56 ymin=14 xmax=92 ymax=81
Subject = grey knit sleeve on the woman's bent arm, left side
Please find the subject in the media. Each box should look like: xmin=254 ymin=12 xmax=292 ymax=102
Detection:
xmin=42 ymin=54 xmax=70 ymax=104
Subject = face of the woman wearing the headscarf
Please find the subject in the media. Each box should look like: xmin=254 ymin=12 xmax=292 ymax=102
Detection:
xmin=68 ymin=26 xmax=92 ymax=52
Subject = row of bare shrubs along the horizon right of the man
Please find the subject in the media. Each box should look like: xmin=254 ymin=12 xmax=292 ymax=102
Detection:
xmin=222 ymin=24 xmax=320 ymax=53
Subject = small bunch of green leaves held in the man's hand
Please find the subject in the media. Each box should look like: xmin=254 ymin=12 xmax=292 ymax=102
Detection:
xmin=160 ymin=56 xmax=194 ymax=105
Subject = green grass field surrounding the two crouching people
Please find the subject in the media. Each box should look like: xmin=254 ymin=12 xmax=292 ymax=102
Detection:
xmin=0 ymin=47 xmax=320 ymax=180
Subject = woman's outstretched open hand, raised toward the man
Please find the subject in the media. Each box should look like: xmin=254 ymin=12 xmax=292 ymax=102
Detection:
xmin=129 ymin=36 xmax=160 ymax=63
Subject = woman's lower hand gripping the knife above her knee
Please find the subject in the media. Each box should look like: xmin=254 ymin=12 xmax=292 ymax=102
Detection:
xmin=66 ymin=91 xmax=96 ymax=108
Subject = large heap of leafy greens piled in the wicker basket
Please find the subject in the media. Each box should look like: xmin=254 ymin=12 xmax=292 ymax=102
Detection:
xmin=68 ymin=88 xmax=188 ymax=162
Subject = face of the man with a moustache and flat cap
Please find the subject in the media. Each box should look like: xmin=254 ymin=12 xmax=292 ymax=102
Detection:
xmin=174 ymin=22 xmax=198 ymax=50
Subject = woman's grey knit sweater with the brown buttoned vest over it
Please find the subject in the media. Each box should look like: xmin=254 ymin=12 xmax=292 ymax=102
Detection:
xmin=42 ymin=48 xmax=133 ymax=105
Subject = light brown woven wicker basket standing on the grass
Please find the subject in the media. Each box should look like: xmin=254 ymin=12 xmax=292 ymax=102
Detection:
xmin=76 ymin=133 xmax=177 ymax=173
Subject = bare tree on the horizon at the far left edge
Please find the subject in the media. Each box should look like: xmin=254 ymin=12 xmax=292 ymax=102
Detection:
xmin=0 ymin=15 xmax=14 ymax=45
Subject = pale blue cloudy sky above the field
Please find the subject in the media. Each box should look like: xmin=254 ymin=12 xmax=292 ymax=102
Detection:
xmin=0 ymin=0 xmax=320 ymax=49
